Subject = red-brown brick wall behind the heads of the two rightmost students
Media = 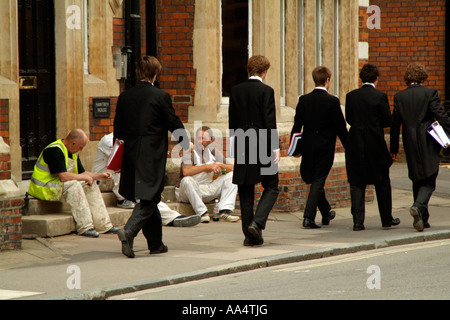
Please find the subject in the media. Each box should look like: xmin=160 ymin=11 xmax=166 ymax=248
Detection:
xmin=362 ymin=0 xmax=446 ymax=107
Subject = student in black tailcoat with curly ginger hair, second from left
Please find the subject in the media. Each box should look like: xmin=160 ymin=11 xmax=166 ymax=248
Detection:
xmin=229 ymin=55 xmax=280 ymax=246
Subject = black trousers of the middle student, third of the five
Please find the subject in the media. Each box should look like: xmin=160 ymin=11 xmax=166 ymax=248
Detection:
xmin=303 ymin=176 xmax=331 ymax=221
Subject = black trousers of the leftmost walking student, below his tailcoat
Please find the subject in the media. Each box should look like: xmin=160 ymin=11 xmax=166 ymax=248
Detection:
xmin=124 ymin=200 xmax=163 ymax=250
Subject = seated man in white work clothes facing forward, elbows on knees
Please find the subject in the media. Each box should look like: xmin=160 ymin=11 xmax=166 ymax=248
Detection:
xmin=175 ymin=126 xmax=239 ymax=223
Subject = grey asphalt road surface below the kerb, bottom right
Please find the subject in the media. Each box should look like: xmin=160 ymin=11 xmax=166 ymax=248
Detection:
xmin=113 ymin=240 xmax=450 ymax=302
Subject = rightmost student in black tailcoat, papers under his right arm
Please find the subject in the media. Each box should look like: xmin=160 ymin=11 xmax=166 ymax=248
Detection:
xmin=391 ymin=63 xmax=450 ymax=232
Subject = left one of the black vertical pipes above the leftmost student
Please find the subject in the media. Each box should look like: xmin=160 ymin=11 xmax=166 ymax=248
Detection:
xmin=124 ymin=0 xmax=141 ymax=89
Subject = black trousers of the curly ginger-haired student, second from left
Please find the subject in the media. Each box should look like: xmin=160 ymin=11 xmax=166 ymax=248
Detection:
xmin=238 ymin=173 xmax=279 ymax=238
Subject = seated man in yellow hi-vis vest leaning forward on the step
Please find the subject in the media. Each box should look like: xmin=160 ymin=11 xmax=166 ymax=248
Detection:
xmin=28 ymin=129 xmax=119 ymax=237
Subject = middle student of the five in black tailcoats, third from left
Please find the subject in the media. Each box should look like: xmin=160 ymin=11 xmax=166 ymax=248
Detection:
xmin=291 ymin=66 xmax=348 ymax=228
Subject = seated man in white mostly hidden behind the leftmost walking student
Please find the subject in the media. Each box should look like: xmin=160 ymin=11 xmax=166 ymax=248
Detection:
xmin=92 ymin=132 xmax=200 ymax=227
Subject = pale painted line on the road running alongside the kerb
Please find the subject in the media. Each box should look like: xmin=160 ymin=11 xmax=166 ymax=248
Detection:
xmin=273 ymin=240 xmax=450 ymax=272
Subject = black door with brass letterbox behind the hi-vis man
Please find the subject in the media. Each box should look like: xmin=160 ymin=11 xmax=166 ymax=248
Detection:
xmin=18 ymin=0 xmax=56 ymax=179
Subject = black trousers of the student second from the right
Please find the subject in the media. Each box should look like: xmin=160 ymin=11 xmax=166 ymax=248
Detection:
xmin=350 ymin=173 xmax=393 ymax=225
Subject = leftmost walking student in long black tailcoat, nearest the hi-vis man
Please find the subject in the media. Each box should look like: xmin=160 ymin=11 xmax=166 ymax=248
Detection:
xmin=114 ymin=56 xmax=190 ymax=258
